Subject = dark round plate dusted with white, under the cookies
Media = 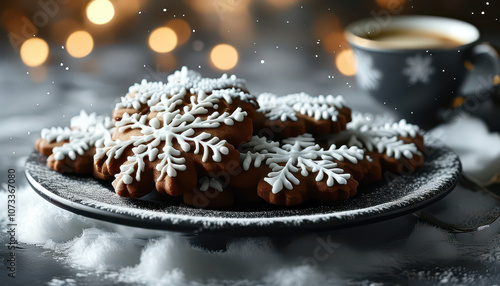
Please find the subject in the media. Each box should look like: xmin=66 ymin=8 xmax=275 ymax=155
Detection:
xmin=26 ymin=138 xmax=461 ymax=236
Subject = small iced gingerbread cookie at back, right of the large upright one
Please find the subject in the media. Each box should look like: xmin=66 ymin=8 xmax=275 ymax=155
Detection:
xmin=254 ymin=93 xmax=351 ymax=140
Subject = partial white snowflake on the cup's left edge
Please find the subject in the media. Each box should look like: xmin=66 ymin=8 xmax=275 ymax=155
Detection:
xmin=354 ymin=51 xmax=383 ymax=90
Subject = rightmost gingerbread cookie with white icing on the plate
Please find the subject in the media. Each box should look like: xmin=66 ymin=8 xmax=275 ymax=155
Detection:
xmin=322 ymin=113 xmax=424 ymax=174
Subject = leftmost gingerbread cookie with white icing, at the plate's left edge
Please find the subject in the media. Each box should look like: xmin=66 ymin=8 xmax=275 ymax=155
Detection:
xmin=35 ymin=110 xmax=114 ymax=179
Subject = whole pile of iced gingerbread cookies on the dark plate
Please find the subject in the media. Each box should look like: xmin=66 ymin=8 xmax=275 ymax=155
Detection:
xmin=36 ymin=67 xmax=424 ymax=208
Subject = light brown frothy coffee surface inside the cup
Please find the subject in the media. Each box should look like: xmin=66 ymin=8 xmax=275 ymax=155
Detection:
xmin=366 ymin=30 xmax=464 ymax=49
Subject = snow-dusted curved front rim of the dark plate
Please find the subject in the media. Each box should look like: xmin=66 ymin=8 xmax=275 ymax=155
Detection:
xmin=25 ymin=139 xmax=462 ymax=235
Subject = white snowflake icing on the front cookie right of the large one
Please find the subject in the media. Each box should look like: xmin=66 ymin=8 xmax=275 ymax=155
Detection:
xmin=241 ymin=134 xmax=364 ymax=194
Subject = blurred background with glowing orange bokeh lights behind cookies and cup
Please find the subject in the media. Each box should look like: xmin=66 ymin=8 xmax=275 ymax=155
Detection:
xmin=0 ymin=0 xmax=500 ymax=172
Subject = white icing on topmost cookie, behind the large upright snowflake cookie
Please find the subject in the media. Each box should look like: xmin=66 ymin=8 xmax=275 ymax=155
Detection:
xmin=115 ymin=66 xmax=250 ymax=110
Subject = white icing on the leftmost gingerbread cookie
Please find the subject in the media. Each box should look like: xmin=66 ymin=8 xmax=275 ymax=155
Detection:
xmin=41 ymin=110 xmax=114 ymax=161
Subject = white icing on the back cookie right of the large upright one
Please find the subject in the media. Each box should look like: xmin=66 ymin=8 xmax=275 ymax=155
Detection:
xmin=257 ymin=92 xmax=345 ymax=121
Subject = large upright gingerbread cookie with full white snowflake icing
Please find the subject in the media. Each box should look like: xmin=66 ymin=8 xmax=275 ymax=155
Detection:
xmin=95 ymin=76 xmax=255 ymax=198
